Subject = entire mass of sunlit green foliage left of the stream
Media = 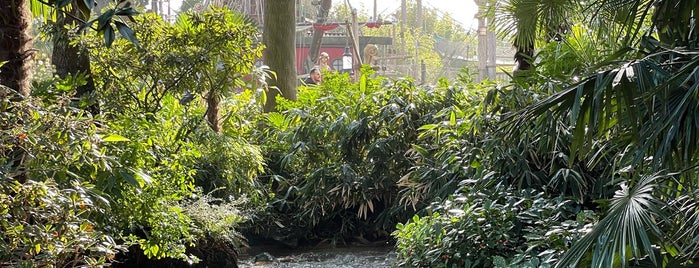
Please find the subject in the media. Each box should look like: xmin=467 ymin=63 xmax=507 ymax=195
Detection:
xmin=0 ymin=6 xmax=264 ymax=266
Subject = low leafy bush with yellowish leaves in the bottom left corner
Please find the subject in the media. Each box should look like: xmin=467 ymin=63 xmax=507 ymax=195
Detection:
xmin=0 ymin=176 xmax=126 ymax=267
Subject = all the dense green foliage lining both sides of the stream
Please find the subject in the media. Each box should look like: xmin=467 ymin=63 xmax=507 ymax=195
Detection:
xmin=6 ymin=0 xmax=699 ymax=267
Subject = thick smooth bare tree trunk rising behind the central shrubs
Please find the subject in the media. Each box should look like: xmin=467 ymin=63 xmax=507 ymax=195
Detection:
xmin=263 ymin=0 xmax=297 ymax=112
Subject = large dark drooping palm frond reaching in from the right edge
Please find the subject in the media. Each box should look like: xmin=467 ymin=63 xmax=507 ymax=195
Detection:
xmin=506 ymin=40 xmax=699 ymax=168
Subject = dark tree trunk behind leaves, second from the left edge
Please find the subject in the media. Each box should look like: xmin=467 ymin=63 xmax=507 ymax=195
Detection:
xmin=51 ymin=3 xmax=99 ymax=114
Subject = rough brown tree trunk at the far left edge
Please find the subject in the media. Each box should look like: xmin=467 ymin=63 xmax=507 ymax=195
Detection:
xmin=0 ymin=0 xmax=34 ymax=97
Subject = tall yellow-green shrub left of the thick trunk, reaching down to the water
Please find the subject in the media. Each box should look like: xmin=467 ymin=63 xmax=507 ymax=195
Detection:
xmin=80 ymin=9 xmax=264 ymax=265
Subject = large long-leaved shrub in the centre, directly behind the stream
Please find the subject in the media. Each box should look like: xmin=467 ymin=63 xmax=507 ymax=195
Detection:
xmin=249 ymin=68 xmax=462 ymax=239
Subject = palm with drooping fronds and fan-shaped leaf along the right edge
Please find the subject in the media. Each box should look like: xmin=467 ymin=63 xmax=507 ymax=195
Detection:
xmin=496 ymin=0 xmax=699 ymax=267
